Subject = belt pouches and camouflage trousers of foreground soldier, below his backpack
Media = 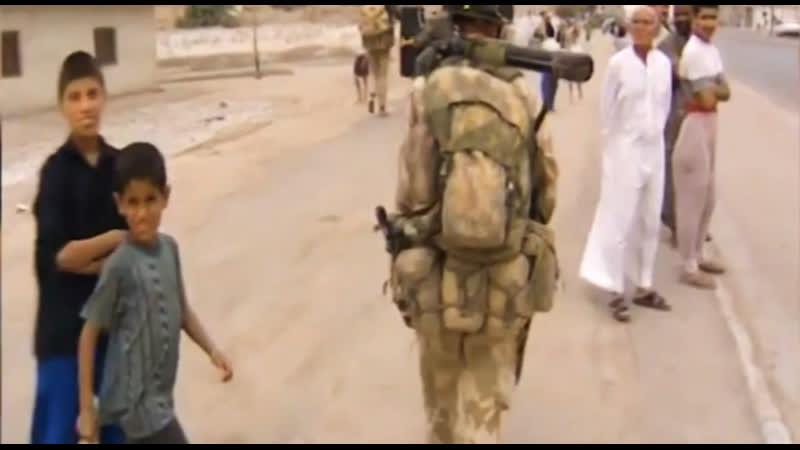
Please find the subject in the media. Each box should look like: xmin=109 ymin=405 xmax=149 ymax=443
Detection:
xmin=390 ymin=223 xmax=557 ymax=443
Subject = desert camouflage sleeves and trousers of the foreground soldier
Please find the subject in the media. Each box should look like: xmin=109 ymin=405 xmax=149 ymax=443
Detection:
xmin=392 ymin=68 xmax=558 ymax=444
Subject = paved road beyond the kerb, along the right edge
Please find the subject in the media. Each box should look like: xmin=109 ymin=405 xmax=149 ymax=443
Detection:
xmin=712 ymin=29 xmax=800 ymax=440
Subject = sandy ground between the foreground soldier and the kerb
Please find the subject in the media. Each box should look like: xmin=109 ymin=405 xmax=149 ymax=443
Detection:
xmin=509 ymin=39 xmax=762 ymax=443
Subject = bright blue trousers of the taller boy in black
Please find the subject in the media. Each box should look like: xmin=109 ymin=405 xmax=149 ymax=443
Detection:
xmin=31 ymin=352 xmax=125 ymax=444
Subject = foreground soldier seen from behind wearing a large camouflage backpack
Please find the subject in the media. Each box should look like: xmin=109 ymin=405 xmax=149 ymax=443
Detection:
xmin=379 ymin=5 xmax=557 ymax=443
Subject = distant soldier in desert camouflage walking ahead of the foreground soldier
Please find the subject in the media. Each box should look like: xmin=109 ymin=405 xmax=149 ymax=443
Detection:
xmin=358 ymin=5 xmax=395 ymax=117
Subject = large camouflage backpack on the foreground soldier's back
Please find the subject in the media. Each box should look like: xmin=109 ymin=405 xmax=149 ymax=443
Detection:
xmin=422 ymin=64 xmax=535 ymax=264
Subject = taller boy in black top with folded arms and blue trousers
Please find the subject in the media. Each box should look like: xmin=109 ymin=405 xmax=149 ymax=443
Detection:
xmin=31 ymin=52 xmax=127 ymax=444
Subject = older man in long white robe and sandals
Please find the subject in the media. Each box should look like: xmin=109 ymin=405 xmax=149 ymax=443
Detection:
xmin=580 ymin=6 xmax=672 ymax=322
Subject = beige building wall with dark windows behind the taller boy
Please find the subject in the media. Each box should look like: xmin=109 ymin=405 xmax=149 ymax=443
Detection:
xmin=0 ymin=5 xmax=157 ymax=115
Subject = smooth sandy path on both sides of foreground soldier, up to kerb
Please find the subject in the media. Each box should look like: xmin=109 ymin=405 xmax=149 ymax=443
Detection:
xmin=2 ymin=46 xmax=760 ymax=443
